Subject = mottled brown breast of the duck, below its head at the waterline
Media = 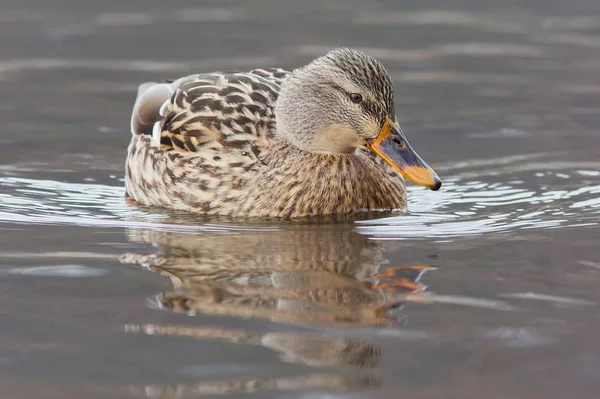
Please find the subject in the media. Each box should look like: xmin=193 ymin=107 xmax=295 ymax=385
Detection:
xmin=249 ymin=142 xmax=406 ymax=217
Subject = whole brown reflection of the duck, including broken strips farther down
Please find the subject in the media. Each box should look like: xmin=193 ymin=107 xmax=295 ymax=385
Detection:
xmin=121 ymin=224 xmax=431 ymax=393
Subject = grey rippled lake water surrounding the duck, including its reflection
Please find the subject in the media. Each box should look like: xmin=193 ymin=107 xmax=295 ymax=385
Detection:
xmin=0 ymin=0 xmax=600 ymax=399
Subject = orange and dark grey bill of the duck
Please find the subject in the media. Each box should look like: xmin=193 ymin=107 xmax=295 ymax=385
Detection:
xmin=367 ymin=119 xmax=442 ymax=191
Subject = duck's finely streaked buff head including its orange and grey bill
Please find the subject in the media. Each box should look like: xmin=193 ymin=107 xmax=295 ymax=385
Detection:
xmin=275 ymin=49 xmax=442 ymax=190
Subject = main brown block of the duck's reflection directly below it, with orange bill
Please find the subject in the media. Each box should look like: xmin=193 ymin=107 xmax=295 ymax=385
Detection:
xmin=121 ymin=225 xmax=426 ymax=325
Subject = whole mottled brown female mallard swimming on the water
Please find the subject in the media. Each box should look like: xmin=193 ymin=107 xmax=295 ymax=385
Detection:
xmin=125 ymin=49 xmax=441 ymax=217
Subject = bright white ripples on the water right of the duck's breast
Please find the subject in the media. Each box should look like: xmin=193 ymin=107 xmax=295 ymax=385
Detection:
xmin=357 ymin=170 xmax=600 ymax=239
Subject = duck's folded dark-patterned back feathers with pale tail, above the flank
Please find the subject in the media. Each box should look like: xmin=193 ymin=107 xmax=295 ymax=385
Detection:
xmin=131 ymin=68 xmax=290 ymax=152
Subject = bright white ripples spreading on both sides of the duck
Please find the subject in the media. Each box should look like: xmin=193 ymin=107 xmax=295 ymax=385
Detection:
xmin=0 ymin=162 xmax=600 ymax=239
